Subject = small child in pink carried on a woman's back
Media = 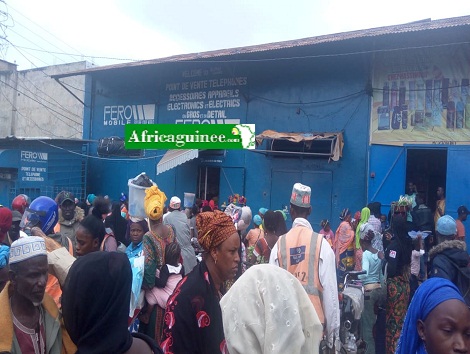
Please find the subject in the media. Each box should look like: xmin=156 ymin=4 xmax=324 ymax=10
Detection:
xmin=145 ymin=242 xmax=184 ymax=309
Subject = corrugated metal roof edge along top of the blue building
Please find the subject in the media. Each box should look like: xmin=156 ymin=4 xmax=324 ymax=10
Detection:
xmin=53 ymin=16 xmax=470 ymax=78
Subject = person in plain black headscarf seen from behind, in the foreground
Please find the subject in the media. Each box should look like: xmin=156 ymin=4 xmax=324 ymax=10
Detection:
xmin=62 ymin=252 xmax=161 ymax=354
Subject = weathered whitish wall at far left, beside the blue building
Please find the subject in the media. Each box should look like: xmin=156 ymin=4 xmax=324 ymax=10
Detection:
xmin=0 ymin=61 xmax=91 ymax=139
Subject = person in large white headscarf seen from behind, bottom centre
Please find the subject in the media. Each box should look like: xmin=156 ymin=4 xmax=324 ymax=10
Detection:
xmin=220 ymin=264 xmax=323 ymax=354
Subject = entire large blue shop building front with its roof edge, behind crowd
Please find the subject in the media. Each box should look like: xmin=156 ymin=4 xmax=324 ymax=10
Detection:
xmin=57 ymin=17 xmax=470 ymax=230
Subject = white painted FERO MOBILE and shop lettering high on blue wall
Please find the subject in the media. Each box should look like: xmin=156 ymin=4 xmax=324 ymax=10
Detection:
xmin=100 ymin=65 xmax=248 ymax=130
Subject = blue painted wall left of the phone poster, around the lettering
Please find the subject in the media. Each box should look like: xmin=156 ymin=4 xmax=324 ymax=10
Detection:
xmin=84 ymin=53 xmax=370 ymax=230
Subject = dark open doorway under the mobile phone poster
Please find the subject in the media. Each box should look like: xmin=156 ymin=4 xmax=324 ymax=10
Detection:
xmin=403 ymin=149 xmax=447 ymax=211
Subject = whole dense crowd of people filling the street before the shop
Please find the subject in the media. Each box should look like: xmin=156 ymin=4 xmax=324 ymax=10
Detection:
xmin=0 ymin=183 xmax=470 ymax=354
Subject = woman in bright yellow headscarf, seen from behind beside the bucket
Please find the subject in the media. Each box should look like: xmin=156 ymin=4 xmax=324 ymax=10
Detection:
xmin=139 ymin=186 xmax=175 ymax=342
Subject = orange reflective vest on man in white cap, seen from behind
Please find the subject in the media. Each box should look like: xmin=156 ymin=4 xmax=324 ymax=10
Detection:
xmin=277 ymin=227 xmax=325 ymax=324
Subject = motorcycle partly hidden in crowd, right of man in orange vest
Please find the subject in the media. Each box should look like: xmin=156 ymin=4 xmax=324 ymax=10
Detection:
xmin=338 ymin=271 xmax=367 ymax=354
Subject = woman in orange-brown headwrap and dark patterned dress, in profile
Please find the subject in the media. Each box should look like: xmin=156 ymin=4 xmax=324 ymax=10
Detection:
xmin=161 ymin=210 xmax=240 ymax=354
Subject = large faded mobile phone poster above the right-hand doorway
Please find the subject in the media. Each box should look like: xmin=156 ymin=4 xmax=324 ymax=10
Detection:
xmin=370 ymin=44 xmax=470 ymax=146
